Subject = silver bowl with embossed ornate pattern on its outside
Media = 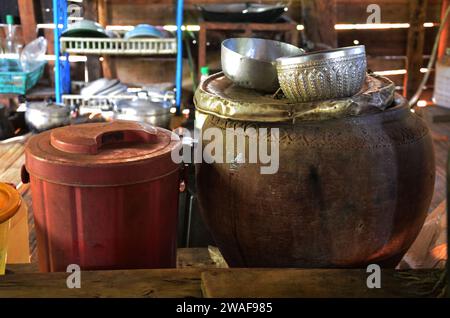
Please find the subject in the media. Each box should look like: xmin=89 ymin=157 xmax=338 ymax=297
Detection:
xmin=277 ymin=45 xmax=367 ymax=102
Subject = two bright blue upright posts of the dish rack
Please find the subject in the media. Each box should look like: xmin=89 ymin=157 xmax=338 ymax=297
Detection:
xmin=53 ymin=0 xmax=184 ymax=113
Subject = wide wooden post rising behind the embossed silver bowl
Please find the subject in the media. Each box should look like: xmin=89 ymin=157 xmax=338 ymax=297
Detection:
xmin=302 ymin=0 xmax=337 ymax=48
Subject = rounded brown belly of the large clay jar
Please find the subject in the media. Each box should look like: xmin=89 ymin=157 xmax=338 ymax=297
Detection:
xmin=197 ymin=115 xmax=434 ymax=267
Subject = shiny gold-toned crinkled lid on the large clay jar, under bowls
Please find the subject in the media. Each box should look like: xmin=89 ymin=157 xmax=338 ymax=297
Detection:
xmin=194 ymin=73 xmax=395 ymax=122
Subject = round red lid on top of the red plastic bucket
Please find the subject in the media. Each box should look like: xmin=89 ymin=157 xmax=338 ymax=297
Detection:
xmin=25 ymin=120 xmax=181 ymax=186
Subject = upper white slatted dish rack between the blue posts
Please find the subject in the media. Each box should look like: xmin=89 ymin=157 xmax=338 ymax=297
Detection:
xmin=60 ymin=37 xmax=177 ymax=55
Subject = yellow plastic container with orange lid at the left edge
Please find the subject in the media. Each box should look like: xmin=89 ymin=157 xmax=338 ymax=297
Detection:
xmin=0 ymin=183 xmax=21 ymax=275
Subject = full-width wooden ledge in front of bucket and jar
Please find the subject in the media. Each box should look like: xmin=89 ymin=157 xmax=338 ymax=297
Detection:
xmin=0 ymin=268 xmax=442 ymax=298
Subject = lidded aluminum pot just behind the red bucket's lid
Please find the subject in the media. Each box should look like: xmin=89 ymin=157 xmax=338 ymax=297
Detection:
xmin=114 ymin=93 xmax=172 ymax=129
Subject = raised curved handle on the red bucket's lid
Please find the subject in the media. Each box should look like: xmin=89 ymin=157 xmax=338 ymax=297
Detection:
xmin=50 ymin=120 xmax=157 ymax=154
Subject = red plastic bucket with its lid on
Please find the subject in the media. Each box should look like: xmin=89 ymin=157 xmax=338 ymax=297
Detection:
xmin=25 ymin=121 xmax=180 ymax=272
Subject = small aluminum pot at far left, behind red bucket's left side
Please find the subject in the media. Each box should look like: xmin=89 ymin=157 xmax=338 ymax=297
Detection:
xmin=25 ymin=102 xmax=70 ymax=132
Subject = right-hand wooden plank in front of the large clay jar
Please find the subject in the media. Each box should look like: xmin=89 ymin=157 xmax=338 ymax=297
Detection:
xmin=201 ymin=269 xmax=442 ymax=298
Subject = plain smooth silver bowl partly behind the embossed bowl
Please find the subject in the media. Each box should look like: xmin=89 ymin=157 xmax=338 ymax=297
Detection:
xmin=221 ymin=38 xmax=304 ymax=93
